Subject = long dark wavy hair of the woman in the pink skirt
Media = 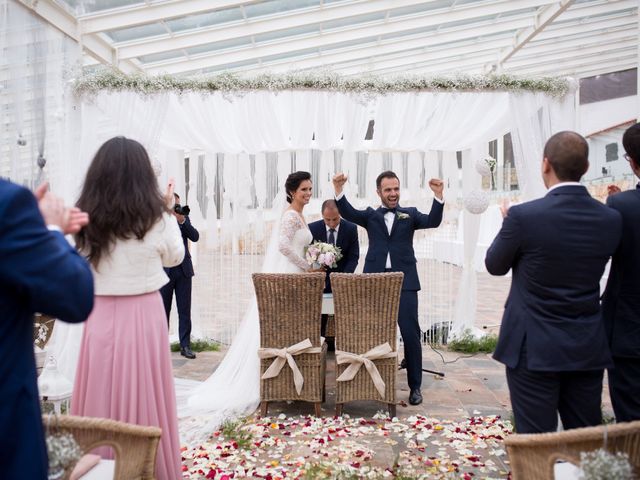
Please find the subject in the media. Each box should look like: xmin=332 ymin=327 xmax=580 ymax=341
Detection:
xmin=75 ymin=137 xmax=167 ymax=269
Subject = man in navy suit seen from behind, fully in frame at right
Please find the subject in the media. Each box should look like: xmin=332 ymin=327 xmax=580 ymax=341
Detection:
xmin=485 ymin=132 xmax=622 ymax=433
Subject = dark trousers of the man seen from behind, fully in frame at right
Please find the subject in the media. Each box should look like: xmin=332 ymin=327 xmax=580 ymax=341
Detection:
xmin=507 ymin=347 xmax=604 ymax=433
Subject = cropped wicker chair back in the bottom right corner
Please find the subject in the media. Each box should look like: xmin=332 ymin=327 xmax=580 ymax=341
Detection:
xmin=505 ymin=421 xmax=640 ymax=480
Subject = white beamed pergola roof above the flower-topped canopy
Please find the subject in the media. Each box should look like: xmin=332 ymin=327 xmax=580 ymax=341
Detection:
xmin=16 ymin=0 xmax=640 ymax=76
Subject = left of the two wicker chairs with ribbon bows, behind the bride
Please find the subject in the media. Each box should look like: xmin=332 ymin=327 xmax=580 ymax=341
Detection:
xmin=253 ymin=273 xmax=327 ymax=416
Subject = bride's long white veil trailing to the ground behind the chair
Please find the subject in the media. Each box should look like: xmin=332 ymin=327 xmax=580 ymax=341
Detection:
xmin=177 ymin=192 xmax=287 ymax=444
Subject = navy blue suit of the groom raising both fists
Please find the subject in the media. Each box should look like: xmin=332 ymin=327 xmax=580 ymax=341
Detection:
xmin=336 ymin=196 xmax=443 ymax=390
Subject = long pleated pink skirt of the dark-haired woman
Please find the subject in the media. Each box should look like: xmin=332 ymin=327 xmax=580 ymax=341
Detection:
xmin=71 ymin=292 xmax=182 ymax=480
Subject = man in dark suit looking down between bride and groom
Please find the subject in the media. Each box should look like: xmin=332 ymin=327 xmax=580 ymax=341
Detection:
xmin=309 ymin=200 xmax=360 ymax=337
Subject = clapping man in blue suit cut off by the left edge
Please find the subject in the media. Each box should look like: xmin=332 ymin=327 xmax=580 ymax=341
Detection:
xmin=0 ymin=180 xmax=93 ymax=480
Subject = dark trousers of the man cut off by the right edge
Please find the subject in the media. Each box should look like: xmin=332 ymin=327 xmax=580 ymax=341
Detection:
xmin=607 ymin=357 xmax=640 ymax=422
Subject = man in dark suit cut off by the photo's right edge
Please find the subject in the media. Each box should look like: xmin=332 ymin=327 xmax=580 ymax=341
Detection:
xmin=602 ymin=123 xmax=640 ymax=422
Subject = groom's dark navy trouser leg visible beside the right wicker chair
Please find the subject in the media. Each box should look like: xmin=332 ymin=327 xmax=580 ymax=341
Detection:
xmin=398 ymin=290 xmax=422 ymax=390
